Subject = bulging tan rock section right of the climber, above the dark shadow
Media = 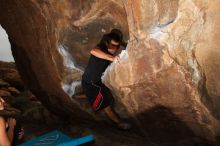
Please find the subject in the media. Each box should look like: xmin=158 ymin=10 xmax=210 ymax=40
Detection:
xmin=104 ymin=0 xmax=220 ymax=139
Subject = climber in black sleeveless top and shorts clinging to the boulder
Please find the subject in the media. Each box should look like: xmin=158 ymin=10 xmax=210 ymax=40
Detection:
xmin=82 ymin=29 xmax=131 ymax=130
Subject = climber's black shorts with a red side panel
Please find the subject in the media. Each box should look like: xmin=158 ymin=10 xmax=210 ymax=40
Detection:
xmin=82 ymin=81 xmax=114 ymax=111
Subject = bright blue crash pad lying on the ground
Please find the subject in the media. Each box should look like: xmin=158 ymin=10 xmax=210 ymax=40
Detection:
xmin=19 ymin=130 xmax=95 ymax=146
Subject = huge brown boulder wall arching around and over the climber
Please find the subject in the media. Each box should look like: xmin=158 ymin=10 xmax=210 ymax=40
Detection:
xmin=0 ymin=0 xmax=220 ymax=144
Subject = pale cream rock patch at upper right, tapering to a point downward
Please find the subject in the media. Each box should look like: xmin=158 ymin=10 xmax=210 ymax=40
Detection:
xmin=160 ymin=0 xmax=205 ymax=84
